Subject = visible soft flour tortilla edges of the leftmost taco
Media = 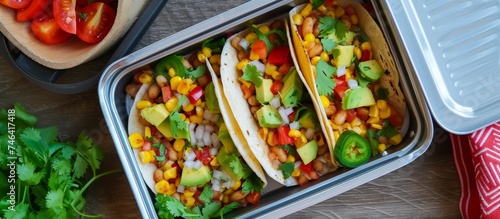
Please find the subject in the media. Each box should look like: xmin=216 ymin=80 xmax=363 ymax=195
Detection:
xmin=128 ymin=65 xmax=267 ymax=193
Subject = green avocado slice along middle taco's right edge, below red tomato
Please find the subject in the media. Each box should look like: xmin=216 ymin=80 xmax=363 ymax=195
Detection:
xmin=280 ymin=67 xmax=304 ymax=107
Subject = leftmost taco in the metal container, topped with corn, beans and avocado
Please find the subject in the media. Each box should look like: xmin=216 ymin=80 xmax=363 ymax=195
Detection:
xmin=128 ymin=44 xmax=267 ymax=218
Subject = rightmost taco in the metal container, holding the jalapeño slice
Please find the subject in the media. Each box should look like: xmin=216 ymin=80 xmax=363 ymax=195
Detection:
xmin=289 ymin=0 xmax=406 ymax=167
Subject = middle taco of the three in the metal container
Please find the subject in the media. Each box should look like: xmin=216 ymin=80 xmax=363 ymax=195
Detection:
xmin=220 ymin=19 xmax=336 ymax=186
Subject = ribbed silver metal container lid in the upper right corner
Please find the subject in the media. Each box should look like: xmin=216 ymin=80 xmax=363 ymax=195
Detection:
xmin=379 ymin=0 xmax=500 ymax=134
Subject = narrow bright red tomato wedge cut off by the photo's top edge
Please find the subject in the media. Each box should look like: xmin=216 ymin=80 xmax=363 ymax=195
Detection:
xmin=52 ymin=0 xmax=76 ymax=34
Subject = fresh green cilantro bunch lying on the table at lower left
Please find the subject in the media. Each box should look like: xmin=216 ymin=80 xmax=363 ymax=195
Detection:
xmin=0 ymin=103 xmax=116 ymax=219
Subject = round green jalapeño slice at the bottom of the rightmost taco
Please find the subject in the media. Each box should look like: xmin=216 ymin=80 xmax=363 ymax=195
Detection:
xmin=334 ymin=130 xmax=371 ymax=168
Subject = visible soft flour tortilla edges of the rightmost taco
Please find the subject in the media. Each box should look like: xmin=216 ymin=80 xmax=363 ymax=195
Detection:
xmin=289 ymin=0 xmax=406 ymax=161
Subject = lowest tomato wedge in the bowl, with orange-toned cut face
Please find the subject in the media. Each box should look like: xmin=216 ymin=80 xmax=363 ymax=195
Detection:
xmin=31 ymin=12 xmax=71 ymax=45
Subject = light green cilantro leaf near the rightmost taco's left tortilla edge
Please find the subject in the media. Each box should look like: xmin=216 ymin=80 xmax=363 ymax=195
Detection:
xmin=316 ymin=59 xmax=337 ymax=96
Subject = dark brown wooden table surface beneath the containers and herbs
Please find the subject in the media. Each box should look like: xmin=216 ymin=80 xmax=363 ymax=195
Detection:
xmin=0 ymin=0 xmax=460 ymax=218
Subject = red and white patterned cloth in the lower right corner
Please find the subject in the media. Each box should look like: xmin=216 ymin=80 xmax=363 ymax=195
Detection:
xmin=450 ymin=122 xmax=500 ymax=219
